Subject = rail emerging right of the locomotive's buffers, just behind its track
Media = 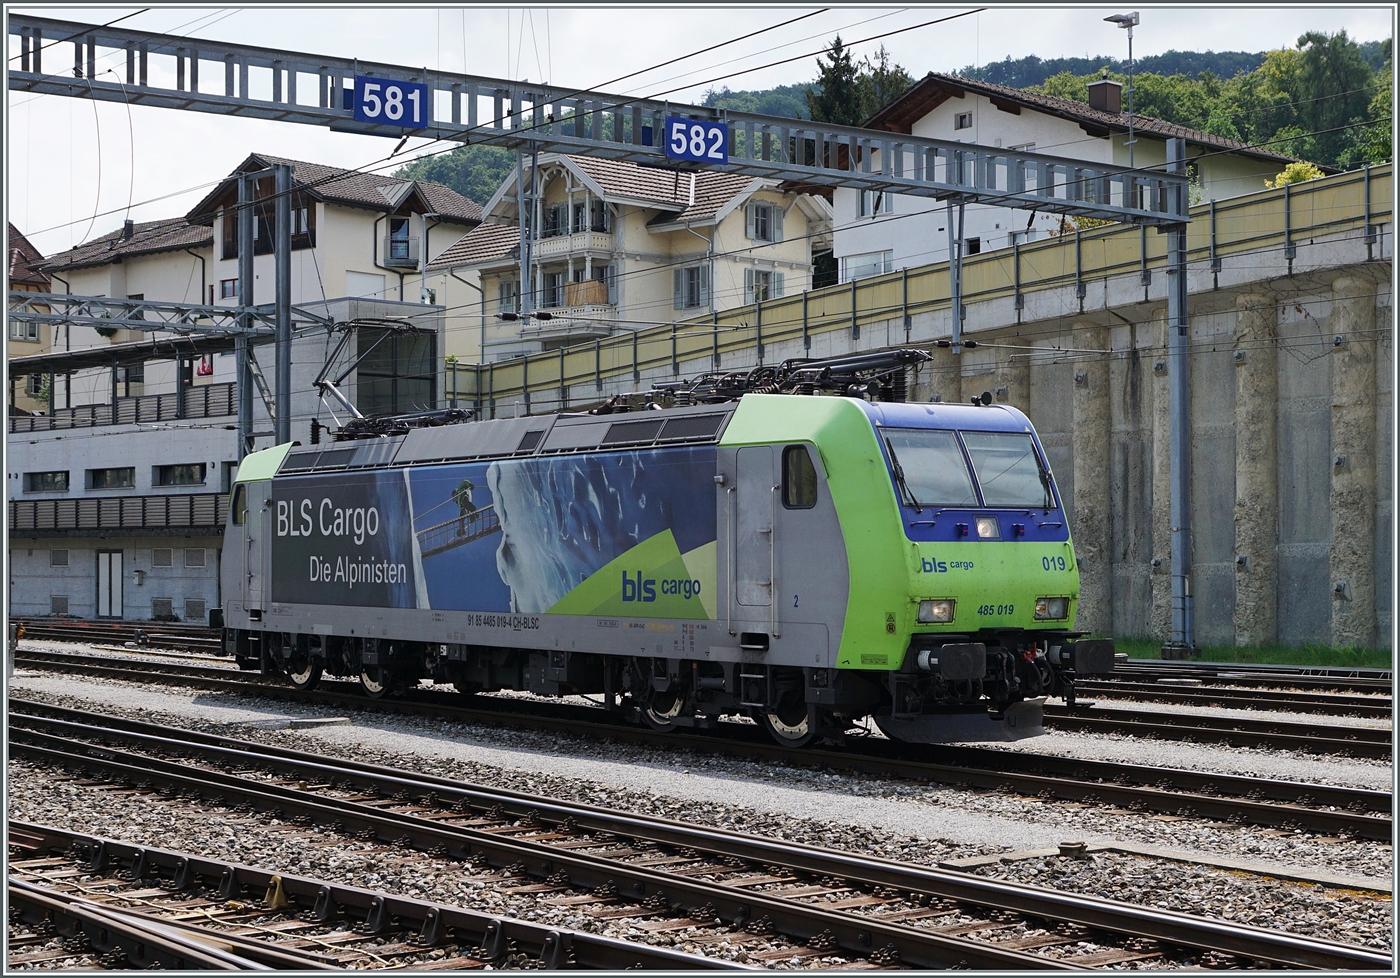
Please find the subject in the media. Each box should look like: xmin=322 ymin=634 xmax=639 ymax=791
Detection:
xmin=1044 ymin=707 xmax=1393 ymax=758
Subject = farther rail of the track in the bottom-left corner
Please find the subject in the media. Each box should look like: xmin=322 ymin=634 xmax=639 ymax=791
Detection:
xmin=10 ymin=822 xmax=750 ymax=971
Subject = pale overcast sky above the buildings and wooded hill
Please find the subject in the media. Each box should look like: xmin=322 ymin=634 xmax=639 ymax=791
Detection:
xmin=6 ymin=4 xmax=1393 ymax=255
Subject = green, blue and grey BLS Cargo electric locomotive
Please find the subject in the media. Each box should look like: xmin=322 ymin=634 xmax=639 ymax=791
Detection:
xmin=220 ymin=351 xmax=1113 ymax=744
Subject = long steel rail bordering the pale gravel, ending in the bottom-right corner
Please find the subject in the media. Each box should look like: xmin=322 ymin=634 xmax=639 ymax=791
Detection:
xmin=8 ymin=723 xmax=1379 ymax=967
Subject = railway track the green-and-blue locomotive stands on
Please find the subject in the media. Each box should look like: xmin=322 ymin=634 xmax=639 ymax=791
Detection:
xmin=11 ymin=653 xmax=1392 ymax=839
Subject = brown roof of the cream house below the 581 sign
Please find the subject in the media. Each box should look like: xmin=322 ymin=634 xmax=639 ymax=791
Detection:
xmin=188 ymin=153 xmax=482 ymax=224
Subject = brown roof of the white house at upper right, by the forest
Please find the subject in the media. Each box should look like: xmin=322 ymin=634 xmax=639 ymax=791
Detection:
xmin=865 ymin=71 xmax=1294 ymax=164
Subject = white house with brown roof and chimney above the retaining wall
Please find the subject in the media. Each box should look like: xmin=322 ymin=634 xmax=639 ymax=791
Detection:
xmin=832 ymin=73 xmax=1294 ymax=281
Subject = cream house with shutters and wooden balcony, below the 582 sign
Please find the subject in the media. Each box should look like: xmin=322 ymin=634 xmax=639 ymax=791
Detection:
xmin=428 ymin=154 xmax=830 ymax=361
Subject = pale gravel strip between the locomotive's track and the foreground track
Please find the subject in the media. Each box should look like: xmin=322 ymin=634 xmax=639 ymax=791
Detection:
xmin=14 ymin=674 xmax=1392 ymax=881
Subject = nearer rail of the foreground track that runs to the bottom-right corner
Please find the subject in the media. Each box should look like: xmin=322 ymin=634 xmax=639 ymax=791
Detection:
xmin=10 ymin=730 xmax=1075 ymax=970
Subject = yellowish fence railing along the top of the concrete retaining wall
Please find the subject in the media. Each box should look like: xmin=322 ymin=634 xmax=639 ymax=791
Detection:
xmin=445 ymin=164 xmax=1393 ymax=418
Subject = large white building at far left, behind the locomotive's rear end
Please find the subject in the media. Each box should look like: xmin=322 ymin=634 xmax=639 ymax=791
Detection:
xmin=6 ymin=155 xmax=480 ymax=621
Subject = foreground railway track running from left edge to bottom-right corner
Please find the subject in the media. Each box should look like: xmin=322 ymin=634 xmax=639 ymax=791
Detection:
xmin=11 ymin=715 xmax=1390 ymax=970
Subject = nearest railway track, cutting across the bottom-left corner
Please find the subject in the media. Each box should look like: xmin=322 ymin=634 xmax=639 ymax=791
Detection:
xmin=7 ymin=820 xmax=739 ymax=971
